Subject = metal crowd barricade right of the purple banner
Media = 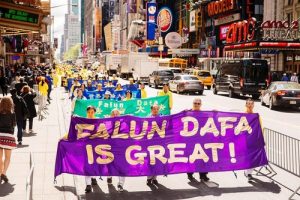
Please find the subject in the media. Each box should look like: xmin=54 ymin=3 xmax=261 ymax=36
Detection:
xmin=264 ymin=128 xmax=300 ymax=199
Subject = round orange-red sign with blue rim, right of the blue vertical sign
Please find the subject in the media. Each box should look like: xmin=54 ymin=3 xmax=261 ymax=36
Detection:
xmin=157 ymin=7 xmax=173 ymax=33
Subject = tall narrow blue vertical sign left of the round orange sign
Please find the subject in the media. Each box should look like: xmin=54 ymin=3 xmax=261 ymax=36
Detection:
xmin=147 ymin=3 xmax=157 ymax=40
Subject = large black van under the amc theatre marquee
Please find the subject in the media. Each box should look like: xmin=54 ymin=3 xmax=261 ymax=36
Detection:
xmin=213 ymin=59 xmax=269 ymax=99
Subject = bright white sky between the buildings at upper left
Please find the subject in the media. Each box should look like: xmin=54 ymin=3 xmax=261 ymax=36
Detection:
xmin=51 ymin=0 xmax=68 ymax=47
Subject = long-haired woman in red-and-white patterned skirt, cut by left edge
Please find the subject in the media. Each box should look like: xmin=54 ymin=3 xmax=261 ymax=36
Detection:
xmin=0 ymin=97 xmax=16 ymax=183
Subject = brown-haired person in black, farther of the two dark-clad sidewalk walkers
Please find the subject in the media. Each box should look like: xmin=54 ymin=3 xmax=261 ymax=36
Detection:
xmin=21 ymin=86 xmax=37 ymax=134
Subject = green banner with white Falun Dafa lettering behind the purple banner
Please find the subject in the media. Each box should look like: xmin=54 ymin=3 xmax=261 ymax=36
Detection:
xmin=73 ymin=96 xmax=170 ymax=118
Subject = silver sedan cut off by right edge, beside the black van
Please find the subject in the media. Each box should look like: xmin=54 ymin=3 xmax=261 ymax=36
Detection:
xmin=260 ymin=81 xmax=300 ymax=110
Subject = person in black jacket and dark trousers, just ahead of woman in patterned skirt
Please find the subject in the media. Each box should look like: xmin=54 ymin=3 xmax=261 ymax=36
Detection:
xmin=10 ymin=89 xmax=29 ymax=145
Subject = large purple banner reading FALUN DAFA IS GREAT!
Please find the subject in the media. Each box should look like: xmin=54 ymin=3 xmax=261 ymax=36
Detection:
xmin=55 ymin=111 xmax=268 ymax=177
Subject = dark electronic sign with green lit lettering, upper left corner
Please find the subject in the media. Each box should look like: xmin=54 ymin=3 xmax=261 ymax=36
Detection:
xmin=0 ymin=6 xmax=39 ymax=24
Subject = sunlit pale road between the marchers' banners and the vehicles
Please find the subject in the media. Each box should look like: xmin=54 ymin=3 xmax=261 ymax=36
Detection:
xmin=141 ymin=83 xmax=300 ymax=139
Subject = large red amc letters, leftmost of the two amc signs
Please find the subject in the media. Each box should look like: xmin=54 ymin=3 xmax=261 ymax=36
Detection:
xmin=226 ymin=17 xmax=256 ymax=44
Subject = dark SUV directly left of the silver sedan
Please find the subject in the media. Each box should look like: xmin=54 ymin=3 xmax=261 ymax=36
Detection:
xmin=149 ymin=69 xmax=174 ymax=88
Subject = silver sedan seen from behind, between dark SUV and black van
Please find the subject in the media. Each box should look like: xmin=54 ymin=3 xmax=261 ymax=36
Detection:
xmin=169 ymin=75 xmax=204 ymax=95
